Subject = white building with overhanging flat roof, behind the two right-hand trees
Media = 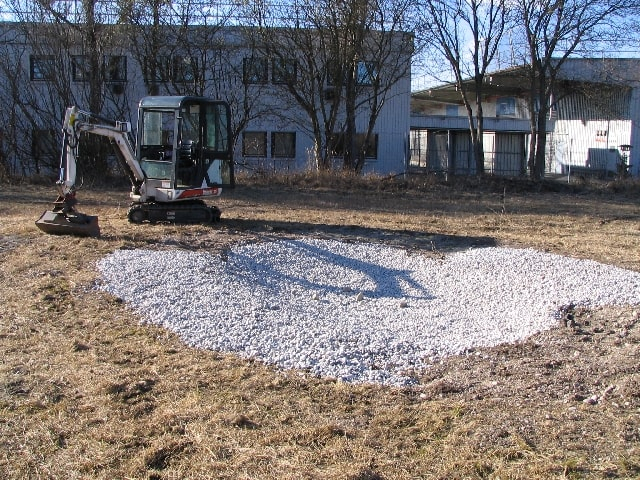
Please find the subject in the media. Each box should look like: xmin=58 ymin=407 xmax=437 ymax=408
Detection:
xmin=409 ymin=59 xmax=640 ymax=176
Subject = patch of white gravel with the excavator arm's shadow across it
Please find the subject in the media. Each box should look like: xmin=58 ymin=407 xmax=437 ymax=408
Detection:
xmin=98 ymin=239 xmax=640 ymax=385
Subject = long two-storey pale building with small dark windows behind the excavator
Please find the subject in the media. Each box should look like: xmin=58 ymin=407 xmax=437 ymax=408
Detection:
xmin=0 ymin=22 xmax=411 ymax=174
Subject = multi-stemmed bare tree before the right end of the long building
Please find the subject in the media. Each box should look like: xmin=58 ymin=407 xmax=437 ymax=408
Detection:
xmin=242 ymin=0 xmax=412 ymax=172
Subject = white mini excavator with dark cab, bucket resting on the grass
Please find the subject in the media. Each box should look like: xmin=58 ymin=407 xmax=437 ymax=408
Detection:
xmin=36 ymin=96 xmax=235 ymax=236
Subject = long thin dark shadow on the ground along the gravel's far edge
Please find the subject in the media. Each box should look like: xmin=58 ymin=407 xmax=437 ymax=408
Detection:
xmin=220 ymin=219 xmax=497 ymax=254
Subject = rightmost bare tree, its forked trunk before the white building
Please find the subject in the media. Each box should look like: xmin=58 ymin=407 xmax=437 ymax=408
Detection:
xmin=515 ymin=0 xmax=638 ymax=179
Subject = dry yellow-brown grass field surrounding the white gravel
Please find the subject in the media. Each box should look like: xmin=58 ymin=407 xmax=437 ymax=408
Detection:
xmin=0 ymin=176 xmax=640 ymax=480
